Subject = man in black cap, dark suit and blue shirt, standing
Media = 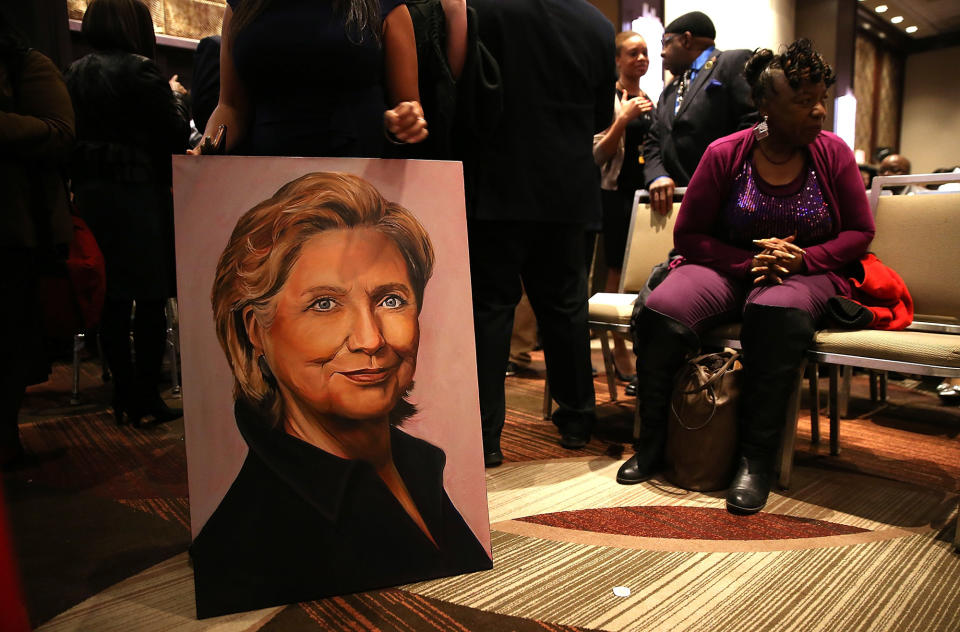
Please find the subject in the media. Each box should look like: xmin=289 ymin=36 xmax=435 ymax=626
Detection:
xmin=644 ymin=11 xmax=757 ymax=214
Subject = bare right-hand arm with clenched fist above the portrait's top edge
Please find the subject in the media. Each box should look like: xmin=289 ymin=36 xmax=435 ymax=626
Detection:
xmin=382 ymin=5 xmax=427 ymax=143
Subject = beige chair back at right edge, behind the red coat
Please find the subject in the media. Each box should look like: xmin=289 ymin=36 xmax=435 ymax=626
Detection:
xmin=870 ymin=193 xmax=960 ymax=318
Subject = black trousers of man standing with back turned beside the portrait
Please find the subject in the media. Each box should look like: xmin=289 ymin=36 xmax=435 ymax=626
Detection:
xmin=468 ymin=220 xmax=595 ymax=450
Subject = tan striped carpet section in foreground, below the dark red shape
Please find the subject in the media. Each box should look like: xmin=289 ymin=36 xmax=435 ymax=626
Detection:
xmin=408 ymin=520 xmax=960 ymax=632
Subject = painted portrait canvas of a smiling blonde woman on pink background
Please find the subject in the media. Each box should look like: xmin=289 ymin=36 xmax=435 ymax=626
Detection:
xmin=174 ymin=156 xmax=492 ymax=618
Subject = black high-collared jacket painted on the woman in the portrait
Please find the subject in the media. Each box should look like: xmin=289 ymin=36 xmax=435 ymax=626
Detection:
xmin=190 ymin=402 xmax=492 ymax=618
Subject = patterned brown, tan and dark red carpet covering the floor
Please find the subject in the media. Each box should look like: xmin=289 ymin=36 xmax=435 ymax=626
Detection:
xmin=5 ymin=350 xmax=960 ymax=632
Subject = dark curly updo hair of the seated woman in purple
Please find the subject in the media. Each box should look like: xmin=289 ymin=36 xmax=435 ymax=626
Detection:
xmin=743 ymin=38 xmax=837 ymax=106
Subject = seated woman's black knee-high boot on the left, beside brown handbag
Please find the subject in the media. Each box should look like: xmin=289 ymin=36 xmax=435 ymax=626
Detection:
xmin=617 ymin=309 xmax=700 ymax=485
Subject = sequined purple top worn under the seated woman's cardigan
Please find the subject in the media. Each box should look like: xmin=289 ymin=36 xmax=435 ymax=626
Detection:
xmin=720 ymin=160 xmax=833 ymax=250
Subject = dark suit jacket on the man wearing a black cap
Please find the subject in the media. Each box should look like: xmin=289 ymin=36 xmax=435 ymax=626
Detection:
xmin=643 ymin=50 xmax=757 ymax=186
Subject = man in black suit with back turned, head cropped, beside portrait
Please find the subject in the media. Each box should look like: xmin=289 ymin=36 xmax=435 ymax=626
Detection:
xmin=464 ymin=0 xmax=616 ymax=467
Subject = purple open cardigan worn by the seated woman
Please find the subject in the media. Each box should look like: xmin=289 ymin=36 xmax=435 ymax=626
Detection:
xmin=673 ymin=129 xmax=874 ymax=288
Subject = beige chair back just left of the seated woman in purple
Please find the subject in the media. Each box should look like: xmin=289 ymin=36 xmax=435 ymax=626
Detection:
xmin=620 ymin=202 xmax=680 ymax=294
